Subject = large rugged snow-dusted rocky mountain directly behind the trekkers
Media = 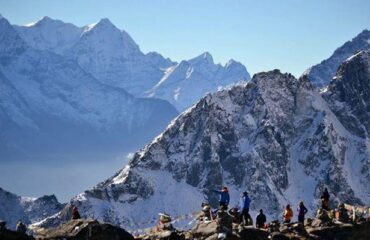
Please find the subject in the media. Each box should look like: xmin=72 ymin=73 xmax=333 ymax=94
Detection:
xmin=35 ymin=52 xmax=370 ymax=229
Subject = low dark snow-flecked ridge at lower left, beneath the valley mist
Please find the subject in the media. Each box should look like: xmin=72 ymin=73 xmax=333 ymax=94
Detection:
xmin=0 ymin=188 xmax=64 ymax=229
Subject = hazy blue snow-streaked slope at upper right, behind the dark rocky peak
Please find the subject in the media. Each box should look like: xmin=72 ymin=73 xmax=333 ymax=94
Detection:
xmin=306 ymin=30 xmax=370 ymax=88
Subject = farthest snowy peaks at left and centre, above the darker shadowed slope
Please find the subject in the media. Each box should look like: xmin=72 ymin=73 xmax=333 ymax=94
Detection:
xmin=15 ymin=17 xmax=250 ymax=111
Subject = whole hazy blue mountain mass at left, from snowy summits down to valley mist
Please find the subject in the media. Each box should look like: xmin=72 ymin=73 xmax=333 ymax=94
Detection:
xmin=0 ymin=14 xmax=249 ymax=165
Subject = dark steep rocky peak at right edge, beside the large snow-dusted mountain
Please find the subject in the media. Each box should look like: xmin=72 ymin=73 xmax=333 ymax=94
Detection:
xmin=324 ymin=50 xmax=370 ymax=138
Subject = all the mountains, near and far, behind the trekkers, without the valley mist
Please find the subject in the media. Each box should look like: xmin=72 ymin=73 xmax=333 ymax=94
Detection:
xmin=0 ymin=14 xmax=370 ymax=232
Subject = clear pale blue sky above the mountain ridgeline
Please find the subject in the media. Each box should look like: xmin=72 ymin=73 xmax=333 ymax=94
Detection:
xmin=0 ymin=0 xmax=370 ymax=76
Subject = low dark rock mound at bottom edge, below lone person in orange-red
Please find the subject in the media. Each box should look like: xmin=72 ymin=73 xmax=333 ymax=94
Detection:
xmin=35 ymin=219 xmax=134 ymax=240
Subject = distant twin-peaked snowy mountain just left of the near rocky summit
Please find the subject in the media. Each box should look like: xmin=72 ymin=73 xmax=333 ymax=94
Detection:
xmin=148 ymin=52 xmax=250 ymax=111
